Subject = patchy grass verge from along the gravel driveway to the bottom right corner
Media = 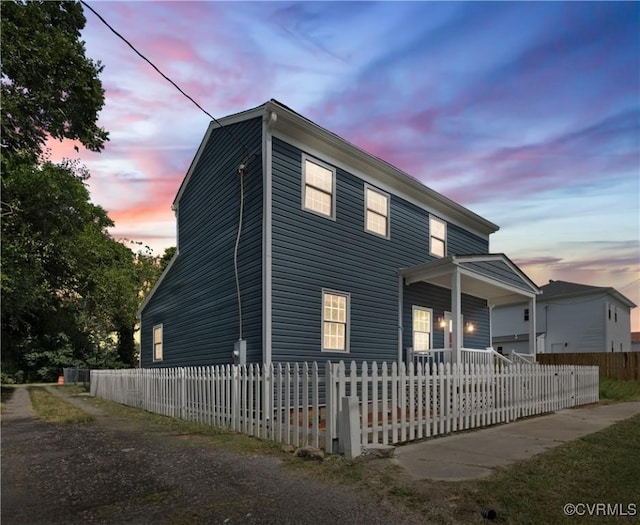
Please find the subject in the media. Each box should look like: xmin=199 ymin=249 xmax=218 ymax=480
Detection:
xmin=85 ymin=390 xmax=640 ymax=524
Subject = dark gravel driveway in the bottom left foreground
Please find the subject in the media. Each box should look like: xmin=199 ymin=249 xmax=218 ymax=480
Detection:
xmin=1 ymin=387 xmax=425 ymax=525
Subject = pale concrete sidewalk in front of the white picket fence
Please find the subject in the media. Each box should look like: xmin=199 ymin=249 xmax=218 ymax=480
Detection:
xmin=393 ymin=402 xmax=640 ymax=481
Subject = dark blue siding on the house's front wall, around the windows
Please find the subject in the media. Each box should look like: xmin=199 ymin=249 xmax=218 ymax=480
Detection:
xmin=272 ymin=139 xmax=488 ymax=362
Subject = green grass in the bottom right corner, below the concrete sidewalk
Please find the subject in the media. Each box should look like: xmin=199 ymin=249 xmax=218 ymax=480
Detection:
xmin=466 ymin=416 xmax=640 ymax=524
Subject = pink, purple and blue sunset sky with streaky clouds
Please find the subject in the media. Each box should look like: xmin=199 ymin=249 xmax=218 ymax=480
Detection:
xmin=50 ymin=0 xmax=640 ymax=330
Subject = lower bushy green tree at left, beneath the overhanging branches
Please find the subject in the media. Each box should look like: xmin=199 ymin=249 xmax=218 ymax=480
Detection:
xmin=0 ymin=162 xmax=139 ymax=376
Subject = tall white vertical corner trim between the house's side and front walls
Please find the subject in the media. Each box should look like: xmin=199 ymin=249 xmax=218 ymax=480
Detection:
xmin=262 ymin=113 xmax=276 ymax=365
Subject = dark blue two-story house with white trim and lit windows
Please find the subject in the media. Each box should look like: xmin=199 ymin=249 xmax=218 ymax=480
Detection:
xmin=140 ymin=100 xmax=538 ymax=367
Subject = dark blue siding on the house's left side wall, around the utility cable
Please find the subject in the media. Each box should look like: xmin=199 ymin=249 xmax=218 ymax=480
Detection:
xmin=141 ymin=119 xmax=263 ymax=367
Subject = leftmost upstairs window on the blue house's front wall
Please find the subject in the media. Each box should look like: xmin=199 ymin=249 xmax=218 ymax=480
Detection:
xmin=302 ymin=155 xmax=336 ymax=219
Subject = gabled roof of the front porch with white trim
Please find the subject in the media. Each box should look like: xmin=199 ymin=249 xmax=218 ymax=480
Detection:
xmin=400 ymin=253 xmax=540 ymax=305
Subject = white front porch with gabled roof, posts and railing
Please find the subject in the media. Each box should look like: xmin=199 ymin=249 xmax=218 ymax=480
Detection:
xmin=398 ymin=254 xmax=540 ymax=365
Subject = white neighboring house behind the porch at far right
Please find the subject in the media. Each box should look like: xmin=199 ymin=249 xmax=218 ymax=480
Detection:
xmin=491 ymin=281 xmax=636 ymax=355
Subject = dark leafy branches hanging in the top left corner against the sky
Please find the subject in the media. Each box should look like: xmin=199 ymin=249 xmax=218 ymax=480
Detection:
xmin=0 ymin=1 xmax=108 ymax=163
